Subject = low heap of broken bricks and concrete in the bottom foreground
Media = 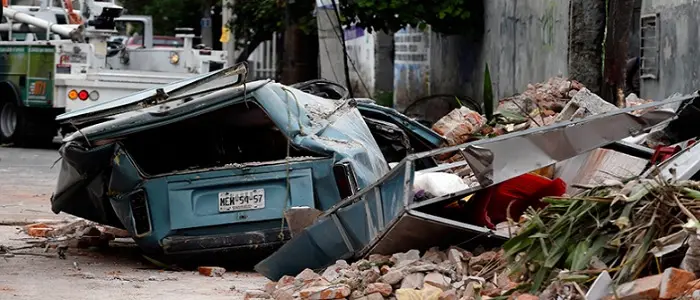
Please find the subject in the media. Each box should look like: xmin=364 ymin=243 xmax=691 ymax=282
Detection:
xmin=250 ymin=247 xmax=517 ymax=300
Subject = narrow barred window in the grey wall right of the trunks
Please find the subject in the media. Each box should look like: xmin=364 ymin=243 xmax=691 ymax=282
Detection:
xmin=639 ymin=14 xmax=660 ymax=79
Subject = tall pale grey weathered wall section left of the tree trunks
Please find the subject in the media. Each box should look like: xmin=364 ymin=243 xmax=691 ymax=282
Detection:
xmin=465 ymin=0 xmax=569 ymax=99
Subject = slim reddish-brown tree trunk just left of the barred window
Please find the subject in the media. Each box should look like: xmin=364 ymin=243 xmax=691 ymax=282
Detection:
xmin=601 ymin=0 xmax=634 ymax=106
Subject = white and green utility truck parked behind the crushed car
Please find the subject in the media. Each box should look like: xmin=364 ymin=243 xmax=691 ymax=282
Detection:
xmin=0 ymin=0 xmax=227 ymax=145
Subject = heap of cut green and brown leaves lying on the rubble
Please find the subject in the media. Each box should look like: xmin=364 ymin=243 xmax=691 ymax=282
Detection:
xmin=503 ymin=179 xmax=700 ymax=292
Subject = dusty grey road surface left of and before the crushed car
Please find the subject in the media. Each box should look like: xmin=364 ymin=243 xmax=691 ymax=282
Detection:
xmin=0 ymin=147 xmax=268 ymax=300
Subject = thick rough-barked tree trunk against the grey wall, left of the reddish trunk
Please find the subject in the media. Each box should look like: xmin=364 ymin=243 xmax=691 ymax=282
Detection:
xmin=569 ymin=0 xmax=606 ymax=95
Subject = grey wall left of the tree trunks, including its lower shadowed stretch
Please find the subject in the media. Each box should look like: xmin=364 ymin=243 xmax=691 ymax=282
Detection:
xmin=394 ymin=0 xmax=569 ymax=108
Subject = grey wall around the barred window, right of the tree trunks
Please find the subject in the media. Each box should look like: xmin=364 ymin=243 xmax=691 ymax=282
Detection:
xmin=640 ymin=0 xmax=700 ymax=100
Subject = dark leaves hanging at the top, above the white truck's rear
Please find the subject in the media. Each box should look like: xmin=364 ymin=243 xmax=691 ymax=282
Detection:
xmin=121 ymin=0 xmax=220 ymax=35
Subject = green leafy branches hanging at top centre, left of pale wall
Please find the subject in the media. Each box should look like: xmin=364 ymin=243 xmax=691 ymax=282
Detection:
xmin=339 ymin=0 xmax=483 ymax=35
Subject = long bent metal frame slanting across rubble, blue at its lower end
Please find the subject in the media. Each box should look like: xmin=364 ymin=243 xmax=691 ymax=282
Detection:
xmin=255 ymin=93 xmax=700 ymax=280
